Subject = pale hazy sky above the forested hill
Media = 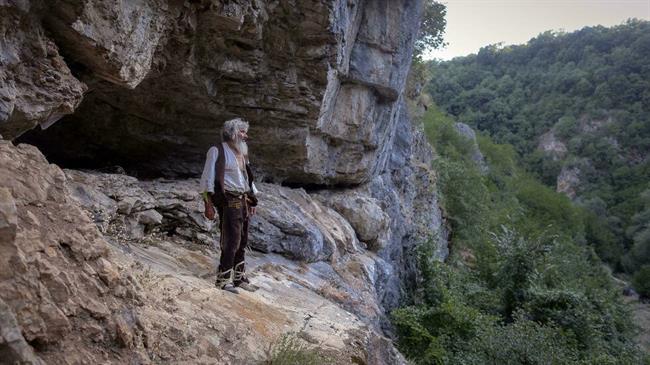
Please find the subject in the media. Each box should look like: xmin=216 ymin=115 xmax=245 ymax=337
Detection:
xmin=426 ymin=0 xmax=650 ymax=60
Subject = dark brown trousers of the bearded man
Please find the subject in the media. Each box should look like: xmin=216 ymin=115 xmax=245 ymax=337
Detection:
xmin=217 ymin=193 xmax=249 ymax=286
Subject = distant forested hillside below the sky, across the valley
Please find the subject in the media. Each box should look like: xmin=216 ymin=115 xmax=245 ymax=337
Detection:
xmin=426 ymin=20 xmax=650 ymax=284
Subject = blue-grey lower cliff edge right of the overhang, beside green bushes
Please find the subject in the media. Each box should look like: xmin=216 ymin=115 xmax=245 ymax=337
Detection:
xmin=368 ymin=103 xmax=449 ymax=310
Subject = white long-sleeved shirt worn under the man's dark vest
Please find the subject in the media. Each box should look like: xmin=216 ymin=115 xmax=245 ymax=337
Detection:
xmin=200 ymin=143 xmax=257 ymax=193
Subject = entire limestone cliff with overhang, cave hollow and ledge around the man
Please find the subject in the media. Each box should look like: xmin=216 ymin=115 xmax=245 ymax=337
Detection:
xmin=0 ymin=0 xmax=447 ymax=364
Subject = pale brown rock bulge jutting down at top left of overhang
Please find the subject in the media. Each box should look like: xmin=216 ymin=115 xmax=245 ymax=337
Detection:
xmin=44 ymin=0 xmax=168 ymax=89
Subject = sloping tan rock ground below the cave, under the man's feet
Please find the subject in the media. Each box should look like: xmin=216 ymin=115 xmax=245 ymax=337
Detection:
xmin=0 ymin=141 xmax=406 ymax=365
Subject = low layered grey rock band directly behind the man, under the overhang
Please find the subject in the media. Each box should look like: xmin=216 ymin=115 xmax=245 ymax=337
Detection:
xmin=65 ymin=170 xmax=360 ymax=262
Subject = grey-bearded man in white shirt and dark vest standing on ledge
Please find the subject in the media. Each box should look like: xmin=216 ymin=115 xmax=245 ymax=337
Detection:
xmin=201 ymin=118 xmax=257 ymax=293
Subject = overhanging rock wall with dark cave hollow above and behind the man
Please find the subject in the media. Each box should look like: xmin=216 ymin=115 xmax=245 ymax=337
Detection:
xmin=13 ymin=0 xmax=421 ymax=185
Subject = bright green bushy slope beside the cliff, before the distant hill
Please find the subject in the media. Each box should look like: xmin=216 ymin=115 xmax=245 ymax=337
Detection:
xmin=392 ymin=106 xmax=642 ymax=364
